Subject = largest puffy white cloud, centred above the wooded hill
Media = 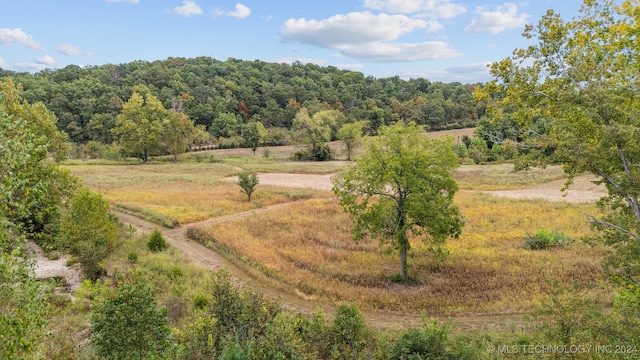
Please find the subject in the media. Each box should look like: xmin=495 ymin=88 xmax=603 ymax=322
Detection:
xmin=280 ymin=12 xmax=429 ymax=48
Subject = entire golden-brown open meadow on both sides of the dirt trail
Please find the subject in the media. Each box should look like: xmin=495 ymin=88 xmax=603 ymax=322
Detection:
xmin=66 ymin=129 xmax=613 ymax=326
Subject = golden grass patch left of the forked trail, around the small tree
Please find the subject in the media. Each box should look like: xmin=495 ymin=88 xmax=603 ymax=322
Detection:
xmin=69 ymin=163 xmax=327 ymax=227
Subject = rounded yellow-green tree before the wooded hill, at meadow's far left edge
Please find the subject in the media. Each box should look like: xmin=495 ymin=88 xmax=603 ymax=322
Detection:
xmin=113 ymin=92 xmax=168 ymax=163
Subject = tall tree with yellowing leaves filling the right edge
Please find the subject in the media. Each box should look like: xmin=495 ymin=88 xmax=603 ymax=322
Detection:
xmin=475 ymin=0 xmax=640 ymax=282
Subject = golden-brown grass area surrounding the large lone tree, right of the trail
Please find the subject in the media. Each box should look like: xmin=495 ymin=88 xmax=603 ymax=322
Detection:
xmin=190 ymin=194 xmax=611 ymax=314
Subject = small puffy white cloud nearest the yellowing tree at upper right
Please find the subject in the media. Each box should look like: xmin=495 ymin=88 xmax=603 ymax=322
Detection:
xmin=464 ymin=3 xmax=529 ymax=35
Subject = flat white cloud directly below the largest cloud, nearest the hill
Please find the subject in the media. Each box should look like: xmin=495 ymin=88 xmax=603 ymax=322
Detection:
xmin=339 ymin=41 xmax=462 ymax=62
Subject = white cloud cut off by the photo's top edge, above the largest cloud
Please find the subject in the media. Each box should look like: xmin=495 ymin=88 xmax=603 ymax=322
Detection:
xmin=364 ymin=0 xmax=467 ymax=19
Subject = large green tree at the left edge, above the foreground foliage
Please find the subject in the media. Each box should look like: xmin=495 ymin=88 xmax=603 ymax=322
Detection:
xmin=0 ymin=81 xmax=78 ymax=240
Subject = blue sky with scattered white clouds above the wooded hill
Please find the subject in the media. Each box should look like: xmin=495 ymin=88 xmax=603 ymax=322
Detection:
xmin=0 ymin=0 xmax=582 ymax=83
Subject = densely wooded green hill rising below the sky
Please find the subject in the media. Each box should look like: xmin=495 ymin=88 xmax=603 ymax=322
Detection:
xmin=0 ymin=57 xmax=484 ymax=143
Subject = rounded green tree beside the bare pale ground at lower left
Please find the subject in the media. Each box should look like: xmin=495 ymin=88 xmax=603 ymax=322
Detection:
xmin=60 ymin=188 xmax=118 ymax=280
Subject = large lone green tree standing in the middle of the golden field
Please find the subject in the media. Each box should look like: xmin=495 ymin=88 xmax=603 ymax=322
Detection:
xmin=333 ymin=123 xmax=463 ymax=280
